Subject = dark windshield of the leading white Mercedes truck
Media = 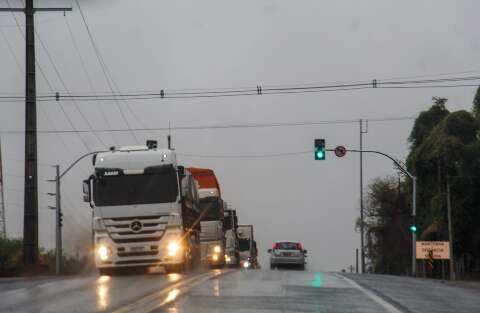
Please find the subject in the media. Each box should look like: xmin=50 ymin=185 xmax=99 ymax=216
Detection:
xmin=94 ymin=168 xmax=178 ymax=206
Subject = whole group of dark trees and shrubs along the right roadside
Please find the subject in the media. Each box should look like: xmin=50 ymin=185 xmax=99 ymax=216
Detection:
xmin=365 ymin=87 xmax=480 ymax=276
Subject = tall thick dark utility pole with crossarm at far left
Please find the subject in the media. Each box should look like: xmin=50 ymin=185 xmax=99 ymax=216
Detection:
xmin=0 ymin=0 xmax=72 ymax=267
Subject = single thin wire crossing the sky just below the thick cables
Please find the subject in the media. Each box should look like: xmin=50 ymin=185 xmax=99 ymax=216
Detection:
xmin=0 ymin=116 xmax=416 ymax=134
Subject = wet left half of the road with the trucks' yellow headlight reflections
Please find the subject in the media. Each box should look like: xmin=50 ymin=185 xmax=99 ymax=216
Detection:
xmin=0 ymin=273 xmax=204 ymax=313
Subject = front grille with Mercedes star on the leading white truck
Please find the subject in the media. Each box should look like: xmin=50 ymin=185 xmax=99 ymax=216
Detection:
xmin=104 ymin=215 xmax=168 ymax=244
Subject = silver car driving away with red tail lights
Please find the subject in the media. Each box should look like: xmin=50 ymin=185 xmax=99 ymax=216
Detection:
xmin=268 ymin=241 xmax=307 ymax=270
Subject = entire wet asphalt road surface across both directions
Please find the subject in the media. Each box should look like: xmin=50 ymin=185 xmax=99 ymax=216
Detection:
xmin=0 ymin=269 xmax=480 ymax=313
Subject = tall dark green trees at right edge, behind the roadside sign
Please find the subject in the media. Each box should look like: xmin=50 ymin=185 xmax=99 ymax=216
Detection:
xmin=407 ymin=95 xmax=480 ymax=272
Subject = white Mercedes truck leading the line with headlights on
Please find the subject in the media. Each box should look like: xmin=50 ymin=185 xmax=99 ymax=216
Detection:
xmin=83 ymin=141 xmax=200 ymax=275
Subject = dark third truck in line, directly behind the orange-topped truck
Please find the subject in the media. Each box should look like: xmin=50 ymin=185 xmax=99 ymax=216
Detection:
xmin=223 ymin=210 xmax=240 ymax=267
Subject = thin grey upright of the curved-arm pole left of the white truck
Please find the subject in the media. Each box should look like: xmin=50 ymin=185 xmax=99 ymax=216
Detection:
xmin=48 ymin=165 xmax=63 ymax=275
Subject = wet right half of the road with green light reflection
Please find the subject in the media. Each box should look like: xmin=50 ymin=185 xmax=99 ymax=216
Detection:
xmin=156 ymin=270 xmax=480 ymax=313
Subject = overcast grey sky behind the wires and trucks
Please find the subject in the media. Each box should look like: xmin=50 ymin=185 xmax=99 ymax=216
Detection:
xmin=0 ymin=0 xmax=480 ymax=270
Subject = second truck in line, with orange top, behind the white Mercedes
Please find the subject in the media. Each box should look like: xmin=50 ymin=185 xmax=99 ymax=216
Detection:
xmin=188 ymin=167 xmax=226 ymax=267
